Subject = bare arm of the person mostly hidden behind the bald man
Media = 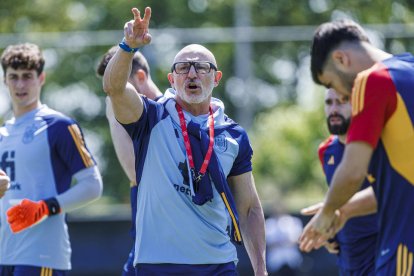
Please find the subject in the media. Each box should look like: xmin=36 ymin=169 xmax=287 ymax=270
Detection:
xmin=106 ymin=98 xmax=136 ymax=183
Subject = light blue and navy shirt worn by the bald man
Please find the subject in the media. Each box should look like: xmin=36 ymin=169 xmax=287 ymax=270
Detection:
xmin=124 ymin=98 xmax=252 ymax=264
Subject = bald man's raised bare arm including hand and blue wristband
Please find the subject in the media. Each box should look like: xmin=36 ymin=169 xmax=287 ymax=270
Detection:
xmin=103 ymin=8 xmax=151 ymax=124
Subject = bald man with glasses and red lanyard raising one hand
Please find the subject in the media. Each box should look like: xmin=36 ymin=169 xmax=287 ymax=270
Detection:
xmin=104 ymin=8 xmax=267 ymax=275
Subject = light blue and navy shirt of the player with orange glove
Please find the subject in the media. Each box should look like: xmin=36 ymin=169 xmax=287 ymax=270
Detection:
xmin=0 ymin=105 xmax=95 ymax=270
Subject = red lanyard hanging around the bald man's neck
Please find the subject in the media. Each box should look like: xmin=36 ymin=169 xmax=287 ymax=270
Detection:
xmin=175 ymin=103 xmax=214 ymax=184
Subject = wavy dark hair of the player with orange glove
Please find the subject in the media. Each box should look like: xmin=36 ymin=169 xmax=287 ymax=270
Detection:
xmin=1 ymin=43 xmax=45 ymax=76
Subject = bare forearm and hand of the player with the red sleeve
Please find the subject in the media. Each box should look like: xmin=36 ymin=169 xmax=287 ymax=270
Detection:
xmin=300 ymin=142 xmax=373 ymax=252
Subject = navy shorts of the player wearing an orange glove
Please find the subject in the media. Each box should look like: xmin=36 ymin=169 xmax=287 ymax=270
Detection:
xmin=0 ymin=265 xmax=67 ymax=276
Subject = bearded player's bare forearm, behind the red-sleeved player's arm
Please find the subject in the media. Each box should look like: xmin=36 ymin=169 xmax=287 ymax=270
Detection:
xmin=340 ymin=186 xmax=377 ymax=219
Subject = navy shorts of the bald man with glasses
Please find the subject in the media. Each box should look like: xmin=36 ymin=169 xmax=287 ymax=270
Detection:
xmin=135 ymin=262 xmax=237 ymax=276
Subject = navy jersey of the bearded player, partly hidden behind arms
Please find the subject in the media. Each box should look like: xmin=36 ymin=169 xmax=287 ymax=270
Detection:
xmin=318 ymin=135 xmax=378 ymax=271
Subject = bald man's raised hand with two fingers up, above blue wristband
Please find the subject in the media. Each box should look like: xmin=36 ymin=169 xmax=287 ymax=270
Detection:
xmin=124 ymin=7 xmax=151 ymax=48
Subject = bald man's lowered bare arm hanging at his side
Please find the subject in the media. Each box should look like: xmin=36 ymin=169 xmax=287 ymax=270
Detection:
xmin=228 ymin=172 xmax=267 ymax=275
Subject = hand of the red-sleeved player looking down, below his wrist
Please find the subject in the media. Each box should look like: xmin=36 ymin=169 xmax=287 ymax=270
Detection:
xmin=299 ymin=209 xmax=335 ymax=252
